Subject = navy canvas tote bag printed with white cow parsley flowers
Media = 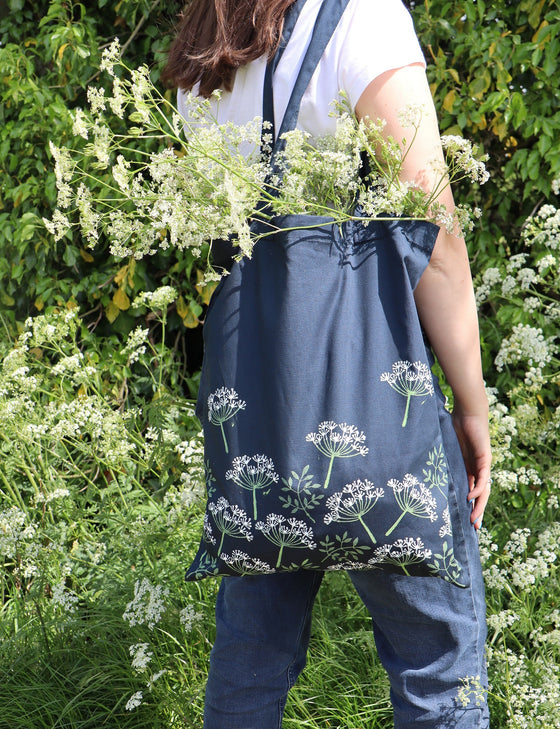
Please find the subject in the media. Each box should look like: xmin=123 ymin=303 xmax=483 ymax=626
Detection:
xmin=187 ymin=0 xmax=469 ymax=586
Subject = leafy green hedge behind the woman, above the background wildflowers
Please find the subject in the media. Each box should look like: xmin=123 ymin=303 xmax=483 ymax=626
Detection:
xmin=0 ymin=0 xmax=560 ymax=332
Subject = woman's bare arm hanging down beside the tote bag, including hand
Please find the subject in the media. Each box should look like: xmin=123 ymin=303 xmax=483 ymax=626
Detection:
xmin=355 ymin=64 xmax=491 ymax=527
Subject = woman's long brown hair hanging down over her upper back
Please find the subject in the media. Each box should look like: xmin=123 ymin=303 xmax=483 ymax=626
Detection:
xmin=162 ymin=0 xmax=294 ymax=96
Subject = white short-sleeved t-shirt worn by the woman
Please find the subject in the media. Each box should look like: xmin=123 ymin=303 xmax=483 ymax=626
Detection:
xmin=178 ymin=0 xmax=425 ymax=137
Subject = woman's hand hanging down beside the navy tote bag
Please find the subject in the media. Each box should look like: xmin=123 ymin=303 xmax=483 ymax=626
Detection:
xmin=453 ymin=408 xmax=492 ymax=529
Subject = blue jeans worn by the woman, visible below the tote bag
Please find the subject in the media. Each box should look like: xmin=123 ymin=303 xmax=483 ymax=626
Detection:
xmin=204 ymin=510 xmax=488 ymax=729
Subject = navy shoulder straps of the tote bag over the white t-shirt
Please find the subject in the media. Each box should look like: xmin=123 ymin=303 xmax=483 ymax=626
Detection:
xmin=263 ymin=0 xmax=350 ymax=149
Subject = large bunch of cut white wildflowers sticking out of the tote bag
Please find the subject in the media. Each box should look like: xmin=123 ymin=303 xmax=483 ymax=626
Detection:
xmin=44 ymin=51 xmax=487 ymax=278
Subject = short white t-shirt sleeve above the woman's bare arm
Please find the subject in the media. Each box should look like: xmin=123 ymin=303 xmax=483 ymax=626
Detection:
xmin=338 ymin=0 xmax=426 ymax=108
